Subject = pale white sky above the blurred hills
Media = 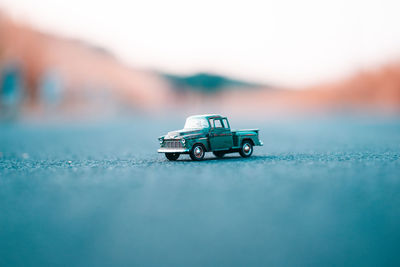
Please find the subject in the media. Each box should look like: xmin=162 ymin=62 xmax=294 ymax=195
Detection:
xmin=0 ymin=0 xmax=400 ymax=87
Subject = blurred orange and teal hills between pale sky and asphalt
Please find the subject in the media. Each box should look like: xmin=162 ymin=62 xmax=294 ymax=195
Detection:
xmin=0 ymin=10 xmax=400 ymax=117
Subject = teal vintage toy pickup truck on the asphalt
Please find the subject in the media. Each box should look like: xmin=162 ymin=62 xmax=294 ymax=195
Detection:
xmin=158 ymin=114 xmax=263 ymax=160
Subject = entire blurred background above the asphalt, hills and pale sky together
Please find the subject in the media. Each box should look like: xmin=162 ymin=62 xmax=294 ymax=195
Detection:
xmin=0 ymin=0 xmax=400 ymax=120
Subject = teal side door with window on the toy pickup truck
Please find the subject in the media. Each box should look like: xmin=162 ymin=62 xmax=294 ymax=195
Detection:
xmin=209 ymin=119 xmax=233 ymax=150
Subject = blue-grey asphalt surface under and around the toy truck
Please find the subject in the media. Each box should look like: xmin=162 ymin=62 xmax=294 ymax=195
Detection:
xmin=0 ymin=117 xmax=400 ymax=266
